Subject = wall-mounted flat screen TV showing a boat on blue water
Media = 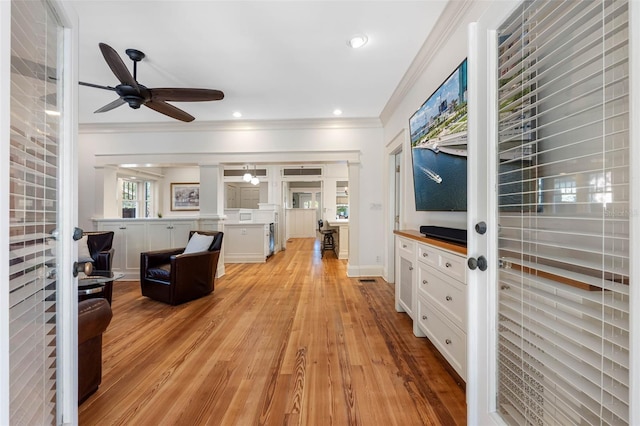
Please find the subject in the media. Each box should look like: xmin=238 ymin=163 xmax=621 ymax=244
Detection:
xmin=409 ymin=59 xmax=467 ymax=211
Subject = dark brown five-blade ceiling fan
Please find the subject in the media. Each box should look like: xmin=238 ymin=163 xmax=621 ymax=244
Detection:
xmin=79 ymin=43 xmax=224 ymax=122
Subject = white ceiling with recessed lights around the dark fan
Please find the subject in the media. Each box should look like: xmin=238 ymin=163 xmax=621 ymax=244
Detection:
xmin=71 ymin=0 xmax=446 ymax=125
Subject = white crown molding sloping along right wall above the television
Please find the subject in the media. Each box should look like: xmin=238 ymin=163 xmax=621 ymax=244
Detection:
xmin=380 ymin=0 xmax=476 ymax=125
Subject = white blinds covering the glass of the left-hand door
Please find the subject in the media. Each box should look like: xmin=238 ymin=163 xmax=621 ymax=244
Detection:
xmin=9 ymin=1 xmax=60 ymax=425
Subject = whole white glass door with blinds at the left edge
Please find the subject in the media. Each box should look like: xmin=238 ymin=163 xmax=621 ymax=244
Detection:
xmin=0 ymin=0 xmax=78 ymax=424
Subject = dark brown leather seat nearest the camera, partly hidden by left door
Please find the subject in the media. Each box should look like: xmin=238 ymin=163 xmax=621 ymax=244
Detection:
xmin=78 ymin=298 xmax=113 ymax=404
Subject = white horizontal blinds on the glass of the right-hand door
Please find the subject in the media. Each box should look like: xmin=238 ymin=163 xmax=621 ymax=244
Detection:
xmin=497 ymin=0 xmax=630 ymax=425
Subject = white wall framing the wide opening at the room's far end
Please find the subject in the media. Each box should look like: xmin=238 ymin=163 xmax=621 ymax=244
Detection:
xmin=78 ymin=120 xmax=384 ymax=273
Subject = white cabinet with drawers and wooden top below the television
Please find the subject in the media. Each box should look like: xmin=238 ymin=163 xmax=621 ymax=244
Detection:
xmin=396 ymin=231 xmax=467 ymax=380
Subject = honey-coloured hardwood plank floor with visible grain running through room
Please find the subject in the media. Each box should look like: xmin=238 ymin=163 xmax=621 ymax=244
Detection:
xmin=79 ymin=238 xmax=466 ymax=425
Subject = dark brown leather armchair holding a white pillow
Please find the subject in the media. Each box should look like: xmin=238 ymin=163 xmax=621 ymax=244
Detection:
xmin=140 ymin=231 xmax=223 ymax=305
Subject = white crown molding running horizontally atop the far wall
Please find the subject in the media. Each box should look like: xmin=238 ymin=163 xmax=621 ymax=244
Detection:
xmin=78 ymin=118 xmax=382 ymax=133
